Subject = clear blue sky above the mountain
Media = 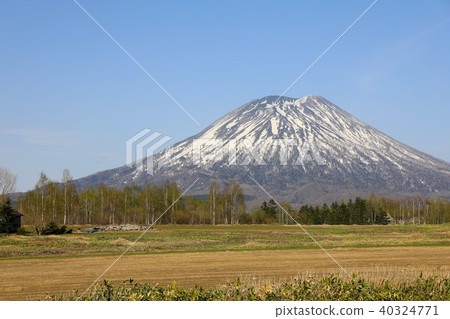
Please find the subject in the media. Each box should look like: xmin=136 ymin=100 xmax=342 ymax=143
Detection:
xmin=0 ymin=0 xmax=450 ymax=191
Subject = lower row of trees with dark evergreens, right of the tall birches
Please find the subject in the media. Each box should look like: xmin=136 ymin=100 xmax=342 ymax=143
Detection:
xmin=251 ymin=195 xmax=450 ymax=225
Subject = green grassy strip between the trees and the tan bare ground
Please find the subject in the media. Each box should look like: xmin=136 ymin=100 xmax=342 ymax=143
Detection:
xmin=0 ymin=224 xmax=450 ymax=258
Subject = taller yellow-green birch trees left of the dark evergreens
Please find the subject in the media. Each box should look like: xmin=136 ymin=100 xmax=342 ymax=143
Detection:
xmin=18 ymin=170 xmax=245 ymax=227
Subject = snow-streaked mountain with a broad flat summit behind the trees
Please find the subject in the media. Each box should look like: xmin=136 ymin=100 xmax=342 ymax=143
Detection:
xmin=77 ymin=96 xmax=450 ymax=203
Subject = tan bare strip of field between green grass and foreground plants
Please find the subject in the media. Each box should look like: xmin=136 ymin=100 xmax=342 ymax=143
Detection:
xmin=0 ymin=247 xmax=450 ymax=300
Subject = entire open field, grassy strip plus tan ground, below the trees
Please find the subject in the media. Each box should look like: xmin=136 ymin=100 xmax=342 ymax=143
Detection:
xmin=0 ymin=225 xmax=450 ymax=300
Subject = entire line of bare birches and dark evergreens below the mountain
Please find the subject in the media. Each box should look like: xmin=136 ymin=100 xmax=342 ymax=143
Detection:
xmin=10 ymin=170 xmax=450 ymax=228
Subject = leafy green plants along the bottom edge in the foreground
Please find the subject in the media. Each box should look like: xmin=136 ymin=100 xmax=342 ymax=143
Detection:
xmin=60 ymin=275 xmax=450 ymax=301
